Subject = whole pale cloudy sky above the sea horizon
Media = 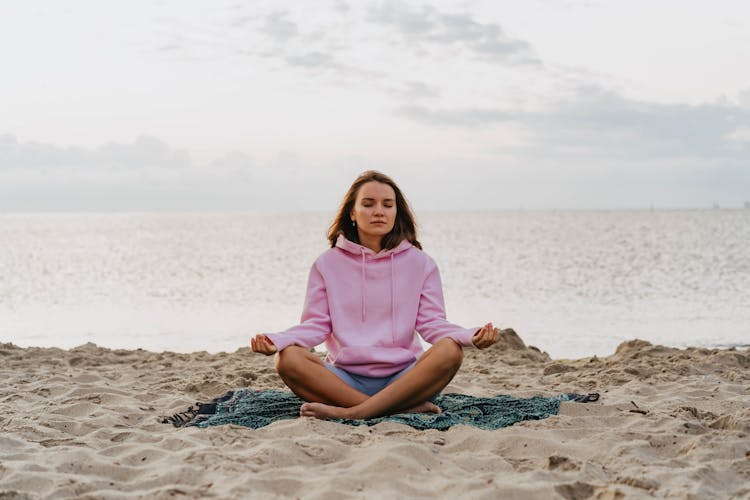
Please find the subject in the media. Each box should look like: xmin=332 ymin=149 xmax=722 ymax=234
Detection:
xmin=0 ymin=0 xmax=750 ymax=212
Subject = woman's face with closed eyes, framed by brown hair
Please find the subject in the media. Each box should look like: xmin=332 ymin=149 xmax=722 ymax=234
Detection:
xmin=349 ymin=181 xmax=396 ymax=239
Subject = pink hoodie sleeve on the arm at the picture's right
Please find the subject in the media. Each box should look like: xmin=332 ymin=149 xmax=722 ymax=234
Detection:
xmin=416 ymin=262 xmax=479 ymax=347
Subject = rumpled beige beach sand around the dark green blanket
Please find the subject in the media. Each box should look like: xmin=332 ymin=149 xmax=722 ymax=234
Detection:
xmin=0 ymin=331 xmax=750 ymax=499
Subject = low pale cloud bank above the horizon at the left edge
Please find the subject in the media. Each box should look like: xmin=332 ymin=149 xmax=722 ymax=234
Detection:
xmin=0 ymin=134 xmax=268 ymax=212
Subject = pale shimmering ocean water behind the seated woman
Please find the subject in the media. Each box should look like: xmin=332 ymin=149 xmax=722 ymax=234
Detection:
xmin=0 ymin=210 xmax=750 ymax=358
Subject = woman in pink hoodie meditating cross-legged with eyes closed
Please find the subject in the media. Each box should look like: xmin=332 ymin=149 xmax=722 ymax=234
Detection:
xmin=250 ymin=170 xmax=498 ymax=419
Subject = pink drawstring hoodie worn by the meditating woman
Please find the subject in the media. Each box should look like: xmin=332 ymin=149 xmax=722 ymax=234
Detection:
xmin=268 ymin=235 xmax=479 ymax=377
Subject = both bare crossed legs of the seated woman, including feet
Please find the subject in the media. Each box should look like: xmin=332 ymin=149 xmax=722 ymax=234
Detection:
xmin=276 ymin=338 xmax=463 ymax=418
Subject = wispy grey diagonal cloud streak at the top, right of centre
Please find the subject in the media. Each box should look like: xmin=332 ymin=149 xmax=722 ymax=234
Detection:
xmin=368 ymin=1 xmax=540 ymax=65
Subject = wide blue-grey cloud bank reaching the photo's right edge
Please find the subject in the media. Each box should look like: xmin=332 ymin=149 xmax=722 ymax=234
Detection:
xmin=396 ymin=87 xmax=750 ymax=162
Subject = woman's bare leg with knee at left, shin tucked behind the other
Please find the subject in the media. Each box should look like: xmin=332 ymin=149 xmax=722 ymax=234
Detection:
xmin=276 ymin=345 xmax=368 ymax=407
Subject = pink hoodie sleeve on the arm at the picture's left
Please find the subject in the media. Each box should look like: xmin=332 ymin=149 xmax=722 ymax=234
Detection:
xmin=267 ymin=263 xmax=331 ymax=352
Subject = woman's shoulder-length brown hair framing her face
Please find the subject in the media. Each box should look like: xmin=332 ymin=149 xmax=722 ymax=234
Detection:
xmin=328 ymin=170 xmax=422 ymax=250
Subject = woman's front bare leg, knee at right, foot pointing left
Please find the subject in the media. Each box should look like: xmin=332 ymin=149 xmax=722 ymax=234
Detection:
xmin=300 ymin=339 xmax=463 ymax=419
